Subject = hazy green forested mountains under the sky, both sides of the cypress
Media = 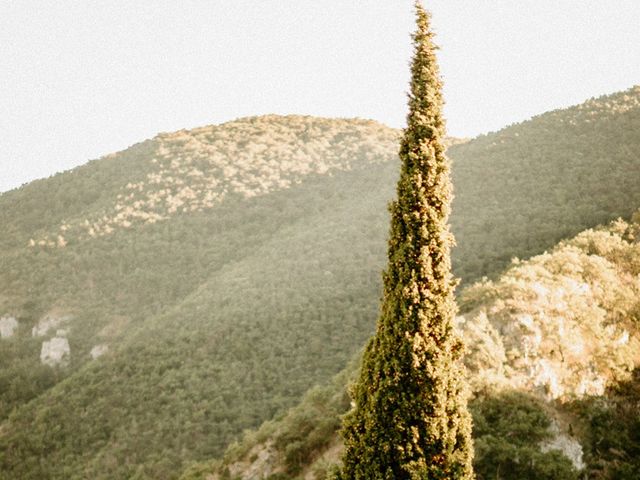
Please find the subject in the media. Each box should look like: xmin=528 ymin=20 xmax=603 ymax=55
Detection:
xmin=0 ymin=87 xmax=640 ymax=479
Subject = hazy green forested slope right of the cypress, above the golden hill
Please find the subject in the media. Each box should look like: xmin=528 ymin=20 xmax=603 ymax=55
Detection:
xmin=449 ymin=86 xmax=640 ymax=280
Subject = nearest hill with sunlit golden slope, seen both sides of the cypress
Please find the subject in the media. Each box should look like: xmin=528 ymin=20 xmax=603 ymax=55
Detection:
xmin=182 ymin=211 xmax=640 ymax=480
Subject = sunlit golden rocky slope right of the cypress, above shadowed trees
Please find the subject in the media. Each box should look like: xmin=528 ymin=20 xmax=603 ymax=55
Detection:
xmin=457 ymin=240 xmax=640 ymax=400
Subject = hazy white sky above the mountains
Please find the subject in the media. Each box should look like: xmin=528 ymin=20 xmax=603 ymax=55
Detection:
xmin=0 ymin=0 xmax=640 ymax=191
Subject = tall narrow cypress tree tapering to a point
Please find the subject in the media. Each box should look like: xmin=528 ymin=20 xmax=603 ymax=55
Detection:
xmin=338 ymin=1 xmax=473 ymax=480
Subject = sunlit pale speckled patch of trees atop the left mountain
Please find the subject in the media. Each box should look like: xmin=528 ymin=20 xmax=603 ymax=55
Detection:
xmin=30 ymin=115 xmax=397 ymax=247
